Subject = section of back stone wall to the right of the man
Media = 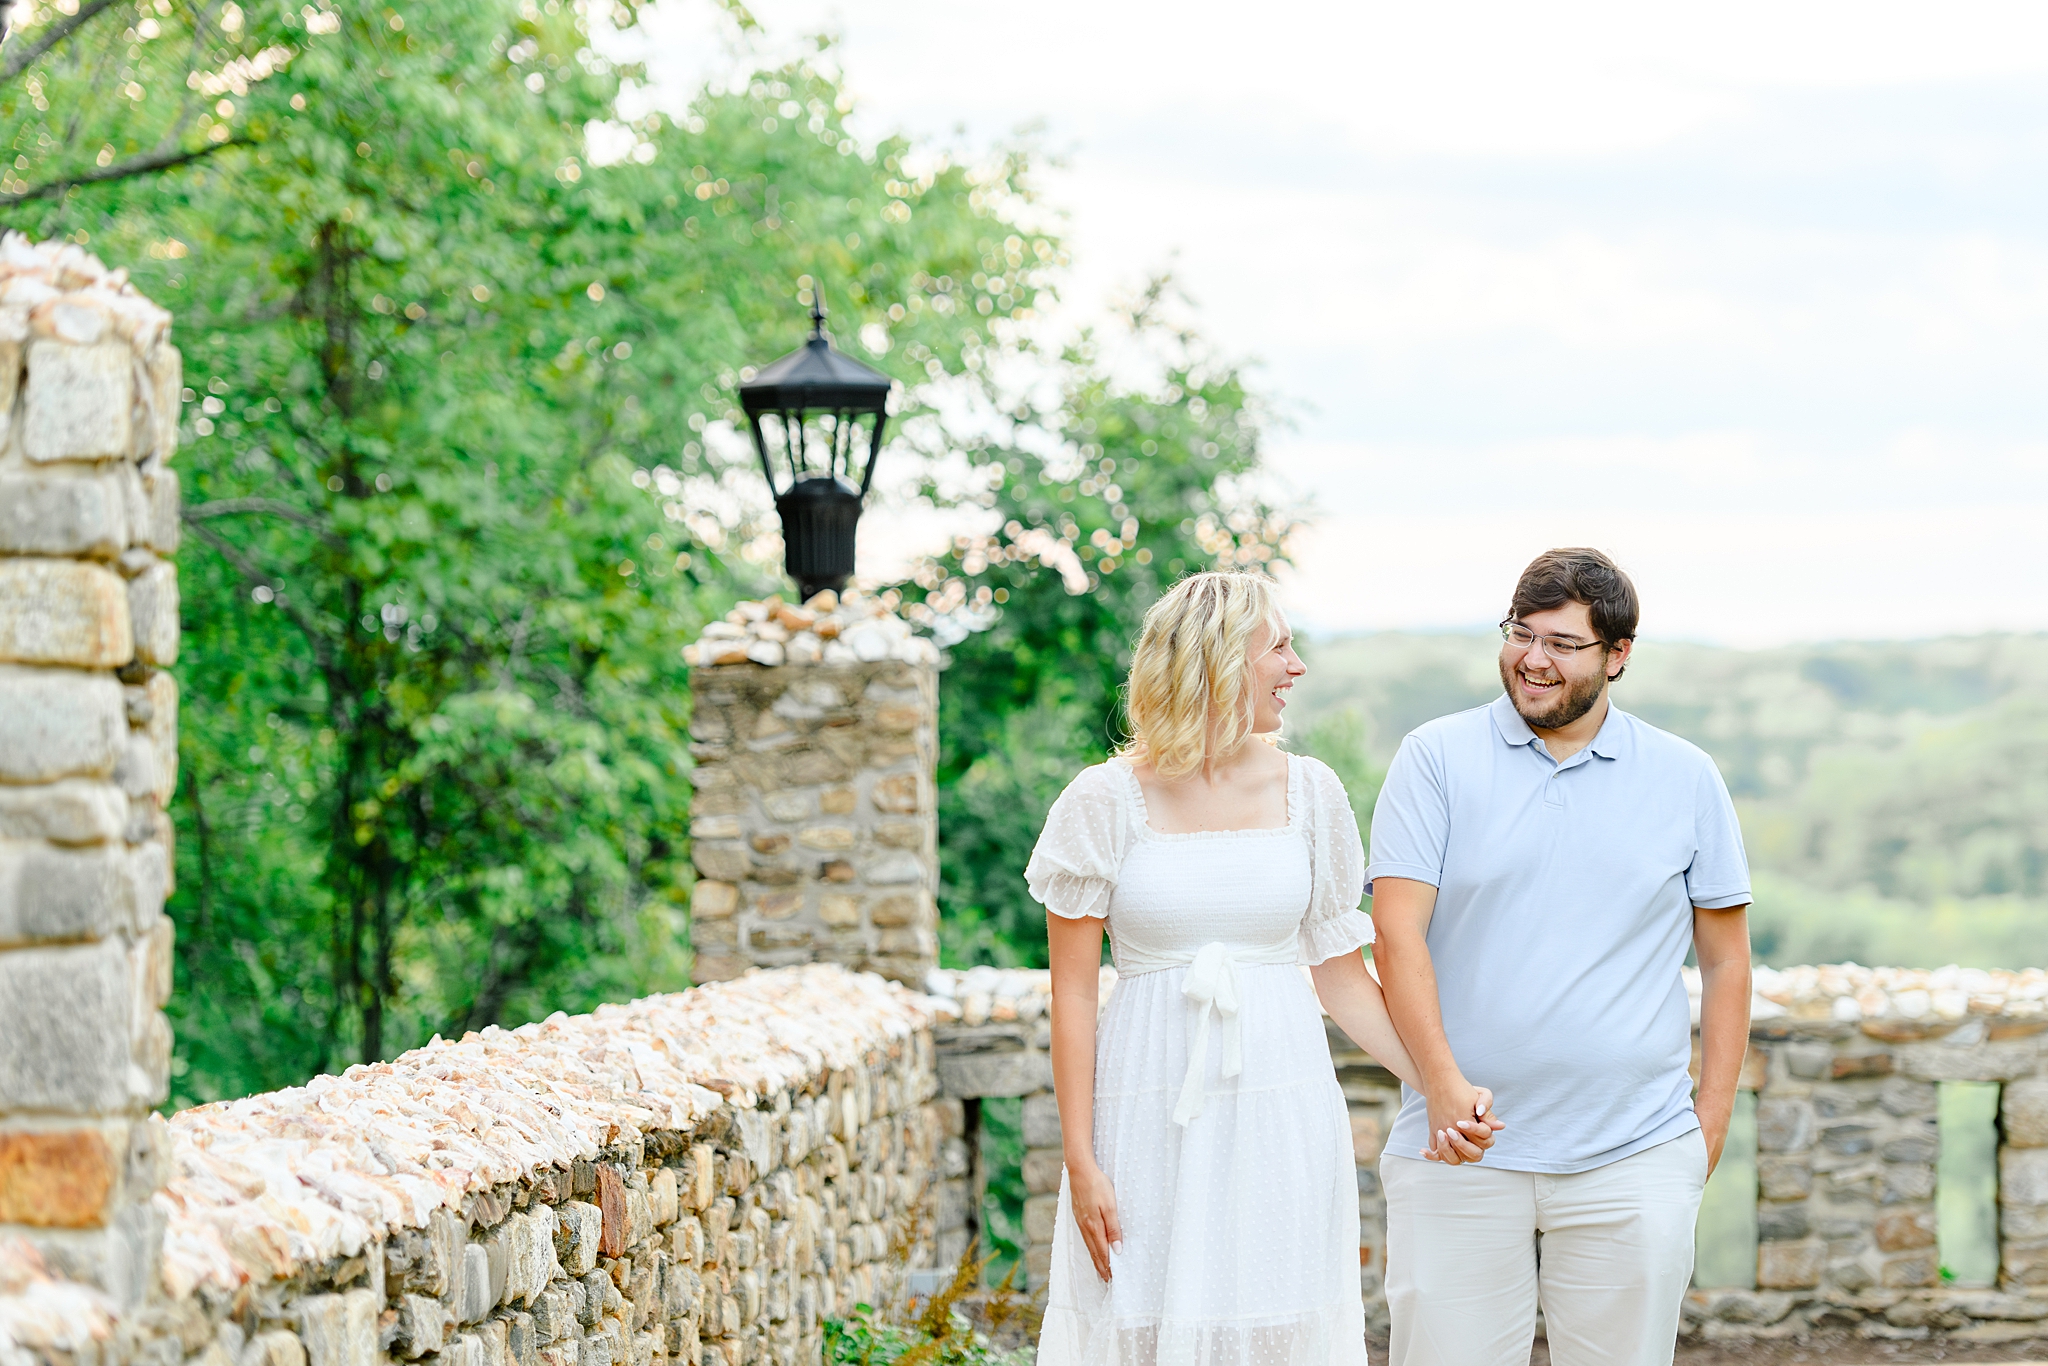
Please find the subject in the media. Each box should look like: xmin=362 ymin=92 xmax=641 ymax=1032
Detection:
xmin=1688 ymin=965 xmax=2048 ymax=1341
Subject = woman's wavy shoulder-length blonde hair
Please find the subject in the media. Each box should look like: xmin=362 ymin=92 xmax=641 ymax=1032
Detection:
xmin=1116 ymin=571 xmax=1280 ymax=778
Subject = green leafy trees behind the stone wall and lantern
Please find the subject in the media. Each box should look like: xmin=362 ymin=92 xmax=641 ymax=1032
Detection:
xmin=12 ymin=0 xmax=1276 ymax=1104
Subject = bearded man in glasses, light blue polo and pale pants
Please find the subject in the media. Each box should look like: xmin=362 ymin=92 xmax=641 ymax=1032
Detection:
xmin=1366 ymin=549 xmax=1749 ymax=1366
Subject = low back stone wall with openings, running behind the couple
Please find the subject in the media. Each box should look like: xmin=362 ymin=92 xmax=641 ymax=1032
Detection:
xmin=928 ymin=967 xmax=2048 ymax=1341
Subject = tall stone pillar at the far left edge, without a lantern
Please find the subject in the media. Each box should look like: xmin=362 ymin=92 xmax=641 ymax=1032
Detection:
xmin=0 ymin=233 xmax=182 ymax=1303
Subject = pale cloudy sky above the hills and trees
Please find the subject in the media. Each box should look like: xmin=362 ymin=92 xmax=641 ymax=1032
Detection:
xmin=622 ymin=0 xmax=2048 ymax=645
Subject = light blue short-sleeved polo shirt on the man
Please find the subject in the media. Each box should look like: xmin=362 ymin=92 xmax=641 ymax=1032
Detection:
xmin=1366 ymin=694 xmax=1749 ymax=1171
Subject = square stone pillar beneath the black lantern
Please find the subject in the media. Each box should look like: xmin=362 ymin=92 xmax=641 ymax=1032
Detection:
xmin=686 ymin=594 xmax=938 ymax=987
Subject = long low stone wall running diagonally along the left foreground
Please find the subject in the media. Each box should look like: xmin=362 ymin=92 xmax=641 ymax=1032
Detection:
xmin=0 ymin=965 xmax=942 ymax=1366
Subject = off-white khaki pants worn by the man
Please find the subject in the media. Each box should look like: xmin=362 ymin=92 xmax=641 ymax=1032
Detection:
xmin=1380 ymin=1128 xmax=1706 ymax=1366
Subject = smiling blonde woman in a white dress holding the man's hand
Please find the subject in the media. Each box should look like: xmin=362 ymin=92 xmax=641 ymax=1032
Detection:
xmin=1026 ymin=573 xmax=1499 ymax=1366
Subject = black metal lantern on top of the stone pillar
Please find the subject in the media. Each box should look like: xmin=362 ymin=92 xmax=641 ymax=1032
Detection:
xmin=739 ymin=289 xmax=891 ymax=598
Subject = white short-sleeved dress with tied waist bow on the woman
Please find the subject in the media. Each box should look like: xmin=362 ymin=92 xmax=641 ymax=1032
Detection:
xmin=1026 ymin=756 xmax=1372 ymax=1366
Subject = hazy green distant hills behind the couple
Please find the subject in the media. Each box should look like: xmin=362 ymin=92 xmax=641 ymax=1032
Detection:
xmin=1288 ymin=633 xmax=2048 ymax=967
